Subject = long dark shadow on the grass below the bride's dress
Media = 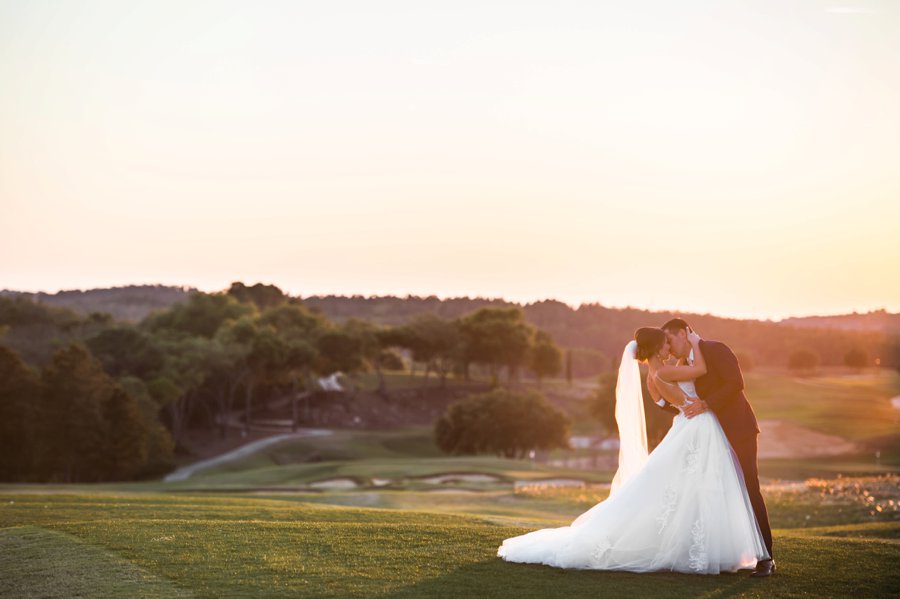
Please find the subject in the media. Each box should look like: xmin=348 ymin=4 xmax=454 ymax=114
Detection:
xmin=379 ymin=558 xmax=768 ymax=599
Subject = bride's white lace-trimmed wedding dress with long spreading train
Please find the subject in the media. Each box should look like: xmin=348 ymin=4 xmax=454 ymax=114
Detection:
xmin=497 ymin=382 xmax=769 ymax=574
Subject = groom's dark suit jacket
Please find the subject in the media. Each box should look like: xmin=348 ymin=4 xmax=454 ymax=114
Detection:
xmin=666 ymin=339 xmax=759 ymax=445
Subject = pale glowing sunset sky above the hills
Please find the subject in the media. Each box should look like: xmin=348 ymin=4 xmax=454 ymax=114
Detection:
xmin=0 ymin=0 xmax=900 ymax=318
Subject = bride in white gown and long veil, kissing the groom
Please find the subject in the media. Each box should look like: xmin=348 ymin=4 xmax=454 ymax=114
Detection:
xmin=497 ymin=327 xmax=769 ymax=574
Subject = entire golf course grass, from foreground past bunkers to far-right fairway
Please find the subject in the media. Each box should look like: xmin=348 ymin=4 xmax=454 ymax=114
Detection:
xmin=0 ymin=373 xmax=900 ymax=599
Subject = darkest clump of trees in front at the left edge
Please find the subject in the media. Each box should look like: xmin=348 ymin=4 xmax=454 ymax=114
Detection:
xmin=0 ymin=344 xmax=172 ymax=482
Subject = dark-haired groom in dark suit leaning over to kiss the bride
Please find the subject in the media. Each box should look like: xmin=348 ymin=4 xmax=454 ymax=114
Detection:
xmin=660 ymin=318 xmax=775 ymax=577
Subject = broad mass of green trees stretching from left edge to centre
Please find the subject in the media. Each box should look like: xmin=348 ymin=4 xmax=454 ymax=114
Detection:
xmin=0 ymin=283 xmax=562 ymax=482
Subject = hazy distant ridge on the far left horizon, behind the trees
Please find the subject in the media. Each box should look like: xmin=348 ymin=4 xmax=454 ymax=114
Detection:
xmin=0 ymin=285 xmax=196 ymax=322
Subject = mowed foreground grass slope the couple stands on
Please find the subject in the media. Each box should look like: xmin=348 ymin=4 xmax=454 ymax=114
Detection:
xmin=0 ymin=491 xmax=900 ymax=598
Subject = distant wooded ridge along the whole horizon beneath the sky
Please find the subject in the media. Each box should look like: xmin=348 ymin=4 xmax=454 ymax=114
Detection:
xmin=0 ymin=285 xmax=900 ymax=367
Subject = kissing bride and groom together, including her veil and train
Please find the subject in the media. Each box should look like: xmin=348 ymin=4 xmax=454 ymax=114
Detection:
xmin=497 ymin=318 xmax=775 ymax=577
